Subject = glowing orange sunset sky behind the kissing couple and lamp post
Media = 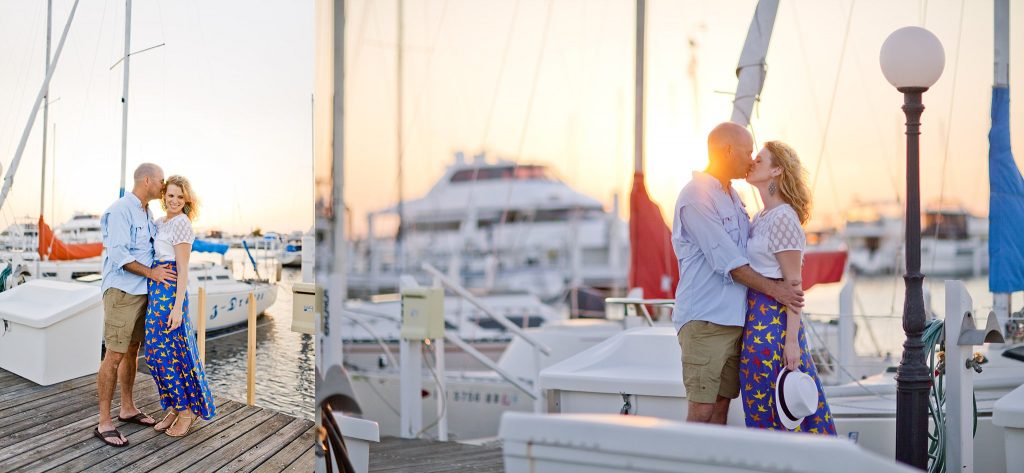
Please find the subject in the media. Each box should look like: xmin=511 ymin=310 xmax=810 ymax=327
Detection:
xmin=337 ymin=0 xmax=1024 ymax=233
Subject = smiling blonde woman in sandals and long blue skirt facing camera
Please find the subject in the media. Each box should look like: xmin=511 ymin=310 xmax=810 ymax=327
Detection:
xmin=145 ymin=176 xmax=215 ymax=437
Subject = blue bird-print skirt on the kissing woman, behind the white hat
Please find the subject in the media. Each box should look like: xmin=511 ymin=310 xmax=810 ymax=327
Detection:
xmin=739 ymin=289 xmax=836 ymax=435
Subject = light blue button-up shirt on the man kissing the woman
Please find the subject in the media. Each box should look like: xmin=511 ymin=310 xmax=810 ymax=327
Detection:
xmin=672 ymin=172 xmax=751 ymax=332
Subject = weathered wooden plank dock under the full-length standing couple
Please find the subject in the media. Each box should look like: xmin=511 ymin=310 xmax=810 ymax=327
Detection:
xmin=0 ymin=370 xmax=313 ymax=473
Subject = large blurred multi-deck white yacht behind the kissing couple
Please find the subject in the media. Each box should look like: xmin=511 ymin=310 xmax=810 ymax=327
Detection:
xmin=348 ymin=153 xmax=629 ymax=300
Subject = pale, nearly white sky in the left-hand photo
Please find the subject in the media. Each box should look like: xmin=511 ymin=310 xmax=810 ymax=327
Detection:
xmin=0 ymin=0 xmax=313 ymax=232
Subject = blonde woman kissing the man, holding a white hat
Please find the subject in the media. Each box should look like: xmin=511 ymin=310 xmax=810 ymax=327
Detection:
xmin=739 ymin=141 xmax=836 ymax=435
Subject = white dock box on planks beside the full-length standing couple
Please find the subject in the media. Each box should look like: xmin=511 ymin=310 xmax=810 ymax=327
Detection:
xmin=0 ymin=280 xmax=103 ymax=386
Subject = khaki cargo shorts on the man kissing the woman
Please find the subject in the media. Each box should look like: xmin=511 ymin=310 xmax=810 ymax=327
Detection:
xmin=678 ymin=320 xmax=743 ymax=404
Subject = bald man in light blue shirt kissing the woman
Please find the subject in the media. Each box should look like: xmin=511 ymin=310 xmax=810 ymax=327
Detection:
xmin=672 ymin=122 xmax=804 ymax=424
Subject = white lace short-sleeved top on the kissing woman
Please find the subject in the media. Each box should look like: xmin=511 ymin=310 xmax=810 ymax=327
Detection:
xmin=746 ymin=204 xmax=807 ymax=278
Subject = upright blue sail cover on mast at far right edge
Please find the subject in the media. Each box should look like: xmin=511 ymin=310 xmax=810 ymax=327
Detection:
xmin=988 ymin=87 xmax=1024 ymax=293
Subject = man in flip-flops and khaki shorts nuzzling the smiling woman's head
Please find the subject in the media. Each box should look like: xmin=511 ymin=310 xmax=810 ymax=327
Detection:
xmin=93 ymin=163 xmax=175 ymax=446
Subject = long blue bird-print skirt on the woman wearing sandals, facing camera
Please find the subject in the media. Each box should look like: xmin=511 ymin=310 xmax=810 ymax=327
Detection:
xmin=145 ymin=261 xmax=216 ymax=420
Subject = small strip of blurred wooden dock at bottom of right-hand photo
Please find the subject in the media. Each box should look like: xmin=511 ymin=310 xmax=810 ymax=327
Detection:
xmin=370 ymin=437 xmax=505 ymax=473
